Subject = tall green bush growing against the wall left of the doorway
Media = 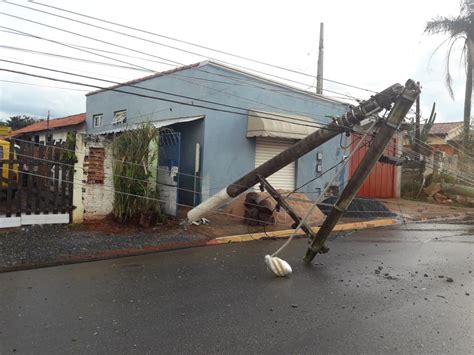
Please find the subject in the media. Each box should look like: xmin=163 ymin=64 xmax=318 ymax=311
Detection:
xmin=112 ymin=123 xmax=160 ymax=222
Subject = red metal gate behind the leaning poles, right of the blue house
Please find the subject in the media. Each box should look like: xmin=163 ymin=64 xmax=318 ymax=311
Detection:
xmin=350 ymin=135 xmax=397 ymax=198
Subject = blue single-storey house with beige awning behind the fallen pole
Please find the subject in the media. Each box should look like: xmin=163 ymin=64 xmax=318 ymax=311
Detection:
xmin=85 ymin=61 xmax=347 ymax=218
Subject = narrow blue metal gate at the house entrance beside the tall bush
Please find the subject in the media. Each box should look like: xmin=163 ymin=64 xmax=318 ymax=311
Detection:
xmin=157 ymin=132 xmax=181 ymax=216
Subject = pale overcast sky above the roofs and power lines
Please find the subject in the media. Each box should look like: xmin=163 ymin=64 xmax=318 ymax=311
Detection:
xmin=0 ymin=0 xmax=465 ymax=122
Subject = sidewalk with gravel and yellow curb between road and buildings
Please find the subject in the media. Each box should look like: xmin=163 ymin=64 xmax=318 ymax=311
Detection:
xmin=0 ymin=200 xmax=474 ymax=272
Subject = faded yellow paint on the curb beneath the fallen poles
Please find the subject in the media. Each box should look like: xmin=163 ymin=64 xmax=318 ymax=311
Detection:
xmin=214 ymin=219 xmax=398 ymax=244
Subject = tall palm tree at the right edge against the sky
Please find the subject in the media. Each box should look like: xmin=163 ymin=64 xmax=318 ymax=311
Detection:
xmin=425 ymin=0 xmax=474 ymax=149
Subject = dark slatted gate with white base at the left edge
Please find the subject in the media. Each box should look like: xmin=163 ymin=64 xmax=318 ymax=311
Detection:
xmin=0 ymin=140 xmax=75 ymax=228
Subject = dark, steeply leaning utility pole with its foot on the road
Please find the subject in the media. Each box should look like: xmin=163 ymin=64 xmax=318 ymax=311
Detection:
xmin=304 ymin=80 xmax=420 ymax=263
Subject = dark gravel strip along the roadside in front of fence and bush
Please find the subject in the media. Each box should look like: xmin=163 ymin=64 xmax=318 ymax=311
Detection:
xmin=0 ymin=225 xmax=207 ymax=272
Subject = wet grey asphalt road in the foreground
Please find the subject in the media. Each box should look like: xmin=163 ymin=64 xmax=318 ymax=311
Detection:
xmin=0 ymin=224 xmax=474 ymax=354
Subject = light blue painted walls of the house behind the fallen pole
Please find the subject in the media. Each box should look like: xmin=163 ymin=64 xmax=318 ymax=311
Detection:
xmin=87 ymin=63 xmax=347 ymax=203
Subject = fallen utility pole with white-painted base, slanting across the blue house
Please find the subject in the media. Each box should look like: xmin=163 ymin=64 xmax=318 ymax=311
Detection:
xmin=187 ymin=84 xmax=403 ymax=223
